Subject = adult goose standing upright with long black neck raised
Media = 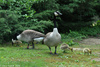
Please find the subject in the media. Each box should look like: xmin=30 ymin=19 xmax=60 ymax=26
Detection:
xmin=44 ymin=11 xmax=62 ymax=54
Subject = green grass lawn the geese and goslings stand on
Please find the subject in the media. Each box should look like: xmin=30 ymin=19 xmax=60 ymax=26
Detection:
xmin=0 ymin=44 xmax=100 ymax=67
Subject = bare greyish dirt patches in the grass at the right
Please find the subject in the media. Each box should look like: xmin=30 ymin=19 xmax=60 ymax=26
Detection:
xmin=73 ymin=38 xmax=100 ymax=61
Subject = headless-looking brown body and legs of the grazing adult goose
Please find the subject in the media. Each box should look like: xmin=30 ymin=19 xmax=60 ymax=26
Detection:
xmin=17 ymin=30 xmax=45 ymax=49
